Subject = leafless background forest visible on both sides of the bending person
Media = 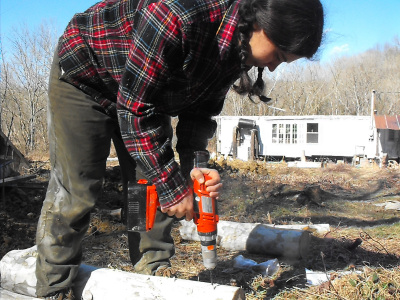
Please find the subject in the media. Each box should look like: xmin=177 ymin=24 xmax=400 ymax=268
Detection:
xmin=0 ymin=23 xmax=400 ymax=155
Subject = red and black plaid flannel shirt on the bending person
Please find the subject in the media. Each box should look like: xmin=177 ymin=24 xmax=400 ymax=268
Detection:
xmin=59 ymin=0 xmax=240 ymax=207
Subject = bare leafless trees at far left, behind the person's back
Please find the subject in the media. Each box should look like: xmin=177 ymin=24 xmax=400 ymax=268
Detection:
xmin=1 ymin=23 xmax=56 ymax=152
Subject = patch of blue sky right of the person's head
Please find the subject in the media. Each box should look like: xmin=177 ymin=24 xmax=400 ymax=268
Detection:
xmin=322 ymin=0 xmax=400 ymax=59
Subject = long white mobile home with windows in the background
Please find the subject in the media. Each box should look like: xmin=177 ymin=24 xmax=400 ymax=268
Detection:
xmin=216 ymin=116 xmax=400 ymax=160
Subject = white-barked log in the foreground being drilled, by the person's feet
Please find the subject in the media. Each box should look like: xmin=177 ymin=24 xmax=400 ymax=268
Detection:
xmin=0 ymin=246 xmax=245 ymax=300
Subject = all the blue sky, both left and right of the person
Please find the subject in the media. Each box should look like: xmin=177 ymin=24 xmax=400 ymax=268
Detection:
xmin=0 ymin=0 xmax=400 ymax=61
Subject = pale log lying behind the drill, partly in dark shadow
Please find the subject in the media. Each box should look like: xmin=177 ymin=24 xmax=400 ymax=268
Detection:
xmin=179 ymin=220 xmax=329 ymax=258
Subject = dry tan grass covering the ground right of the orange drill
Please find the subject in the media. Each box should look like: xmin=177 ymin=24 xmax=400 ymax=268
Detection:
xmin=209 ymin=160 xmax=400 ymax=300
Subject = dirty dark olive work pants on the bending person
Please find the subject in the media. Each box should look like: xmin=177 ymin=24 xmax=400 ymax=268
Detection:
xmin=36 ymin=49 xmax=174 ymax=296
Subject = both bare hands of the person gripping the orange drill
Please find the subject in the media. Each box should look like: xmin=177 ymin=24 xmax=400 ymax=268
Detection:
xmin=161 ymin=168 xmax=222 ymax=221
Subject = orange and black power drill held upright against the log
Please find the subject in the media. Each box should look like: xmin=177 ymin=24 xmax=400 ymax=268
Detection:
xmin=126 ymin=151 xmax=219 ymax=269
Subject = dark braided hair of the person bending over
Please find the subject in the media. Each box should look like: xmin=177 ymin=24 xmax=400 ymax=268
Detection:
xmin=234 ymin=0 xmax=324 ymax=102
